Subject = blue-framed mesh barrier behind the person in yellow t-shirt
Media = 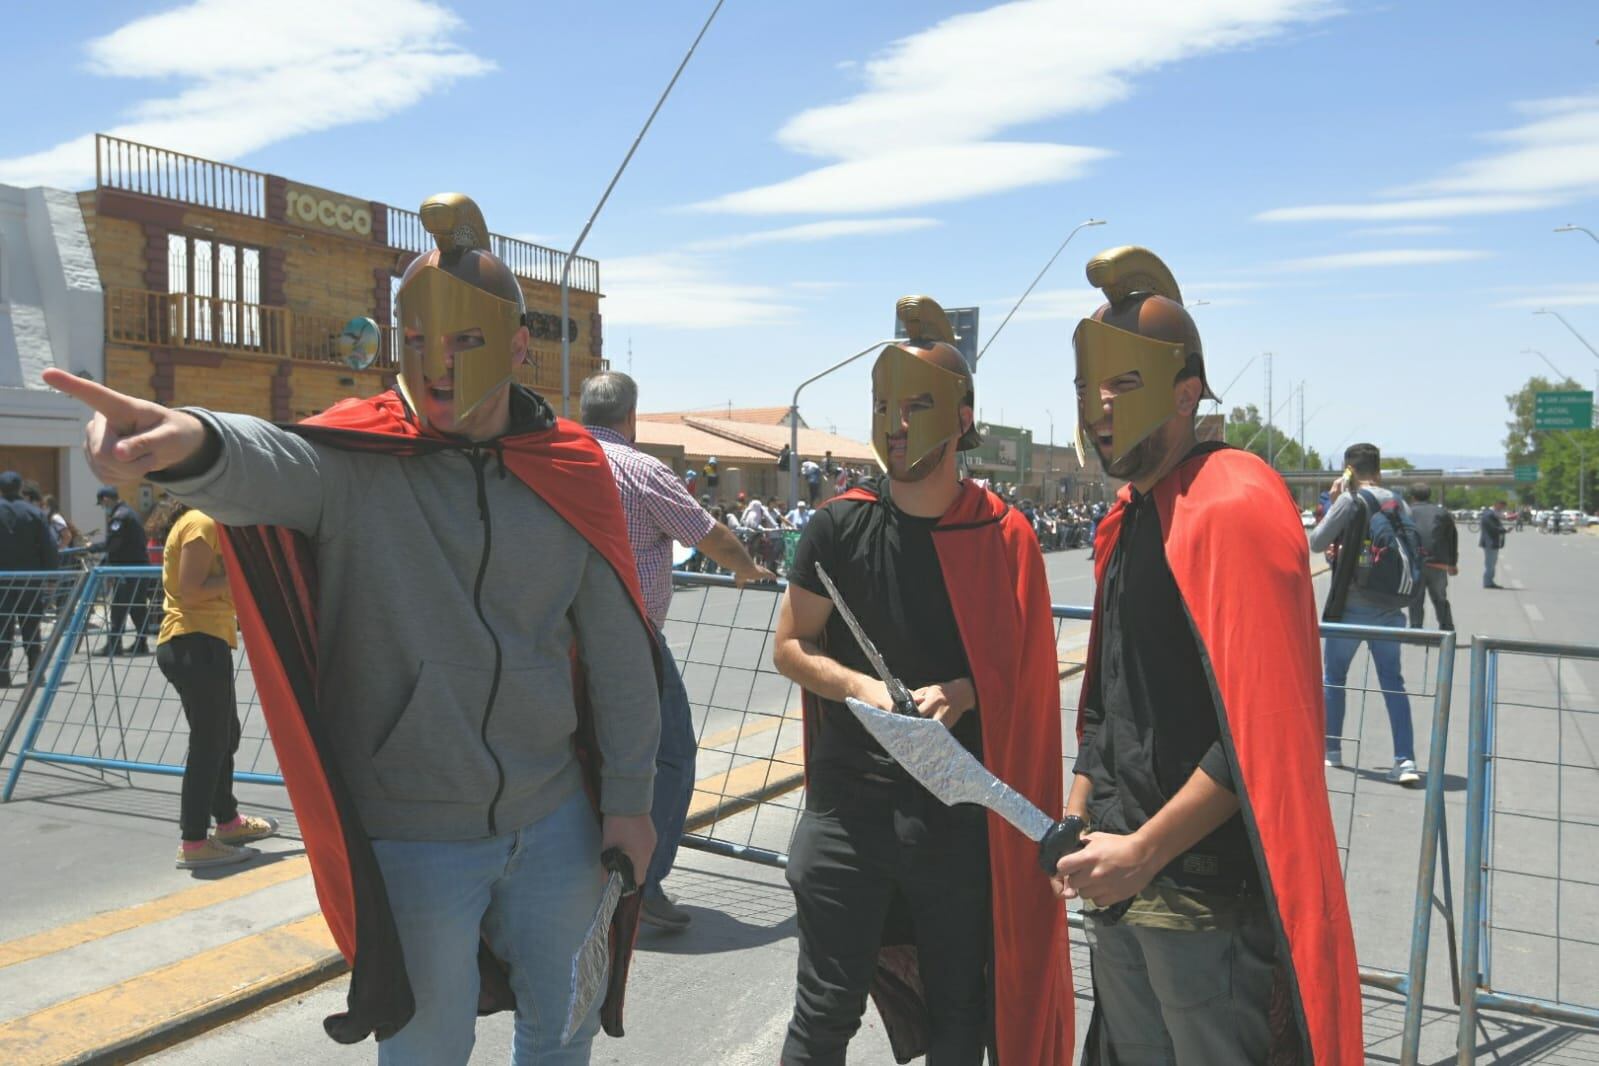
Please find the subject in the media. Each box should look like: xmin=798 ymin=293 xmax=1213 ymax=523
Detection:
xmin=0 ymin=566 xmax=283 ymax=801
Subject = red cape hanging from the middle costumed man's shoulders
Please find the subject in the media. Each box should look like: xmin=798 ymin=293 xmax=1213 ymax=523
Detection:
xmin=804 ymin=481 xmax=1075 ymax=1066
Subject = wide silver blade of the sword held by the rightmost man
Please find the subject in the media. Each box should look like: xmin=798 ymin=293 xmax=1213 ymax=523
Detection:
xmin=844 ymin=697 xmax=1055 ymax=841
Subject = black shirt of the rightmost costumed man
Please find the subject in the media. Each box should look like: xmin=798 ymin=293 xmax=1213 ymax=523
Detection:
xmin=1073 ymin=491 xmax=1260 ymax=893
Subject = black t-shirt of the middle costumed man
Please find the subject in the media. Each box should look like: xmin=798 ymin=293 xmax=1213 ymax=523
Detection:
xmin=788 ymin=479 xmax=982 ymax=780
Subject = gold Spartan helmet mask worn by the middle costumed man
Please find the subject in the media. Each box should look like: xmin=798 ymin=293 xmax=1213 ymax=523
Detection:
xmin=871 ymin=296 xmax=982 ymax=481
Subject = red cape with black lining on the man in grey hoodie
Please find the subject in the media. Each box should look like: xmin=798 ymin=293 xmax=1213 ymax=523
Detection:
xmin=222 ymin=392 xmax=654 ymax=1044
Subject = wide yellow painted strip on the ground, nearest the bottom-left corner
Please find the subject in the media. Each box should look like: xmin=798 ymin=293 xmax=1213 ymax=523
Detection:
xmin=0 ymin=914 xmax=344 ymax=1066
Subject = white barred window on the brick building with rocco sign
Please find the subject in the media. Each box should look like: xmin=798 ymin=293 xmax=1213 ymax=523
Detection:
xmin=166 ymin=233 xmax=261 ymax=348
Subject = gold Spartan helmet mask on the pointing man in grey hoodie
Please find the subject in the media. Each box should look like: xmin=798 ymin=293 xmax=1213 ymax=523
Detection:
xmin=398 ymin=192 xmax=526 ymax=424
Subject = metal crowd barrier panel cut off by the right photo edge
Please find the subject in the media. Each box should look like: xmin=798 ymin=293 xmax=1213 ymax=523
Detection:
xmin=1457 ymin=636 xmax=1599 ymax=1066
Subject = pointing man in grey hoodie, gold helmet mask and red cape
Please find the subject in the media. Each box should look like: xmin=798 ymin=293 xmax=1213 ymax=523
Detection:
xmin=45 ymin=193 xmax=660 ymax=1066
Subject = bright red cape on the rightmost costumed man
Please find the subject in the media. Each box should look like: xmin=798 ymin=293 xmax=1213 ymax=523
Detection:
xmin=1078 ymin=446 xmax=1364 ymax=1066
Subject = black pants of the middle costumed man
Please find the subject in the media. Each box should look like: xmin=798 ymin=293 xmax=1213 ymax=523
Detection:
xmin=782 ymin=769 xmax=993 ymax=1066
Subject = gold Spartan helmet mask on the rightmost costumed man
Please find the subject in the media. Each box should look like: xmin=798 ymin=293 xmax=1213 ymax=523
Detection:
xmin=1071 ymin=252 xmax=1215 ymax=463
